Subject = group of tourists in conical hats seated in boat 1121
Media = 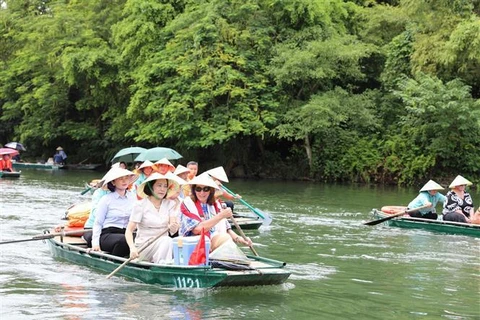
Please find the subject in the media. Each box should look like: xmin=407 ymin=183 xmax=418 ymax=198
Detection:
xmin=75 ymin=158 xmax=252 ymax=263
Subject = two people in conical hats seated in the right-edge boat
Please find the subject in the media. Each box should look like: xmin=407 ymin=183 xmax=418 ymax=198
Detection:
xmin=408 ymin=175 xmax=480 ymax=224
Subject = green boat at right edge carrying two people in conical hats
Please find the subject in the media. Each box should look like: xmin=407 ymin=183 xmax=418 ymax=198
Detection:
xmin=373 ymin=209 xmax=480 ymax=237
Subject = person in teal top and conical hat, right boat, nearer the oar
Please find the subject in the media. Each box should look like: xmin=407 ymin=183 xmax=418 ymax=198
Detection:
xmin=408 ymin=180 xmax=447 ymax=220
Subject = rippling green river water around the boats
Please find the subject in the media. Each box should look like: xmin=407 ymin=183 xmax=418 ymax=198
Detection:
xmin=0 ymin=170 xmax=480 ymax=320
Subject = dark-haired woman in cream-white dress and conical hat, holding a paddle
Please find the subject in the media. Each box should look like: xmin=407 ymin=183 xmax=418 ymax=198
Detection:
xmin=125 ymin=173 xmax=186 ymax=263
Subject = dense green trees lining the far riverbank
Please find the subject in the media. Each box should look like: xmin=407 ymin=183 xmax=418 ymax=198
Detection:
xmin=0 ymin=0 xmax=480 ymax=184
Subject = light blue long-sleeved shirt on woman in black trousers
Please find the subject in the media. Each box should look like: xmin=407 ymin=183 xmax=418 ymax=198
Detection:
xmin=92 ymin=191 xmax=136 ymax=247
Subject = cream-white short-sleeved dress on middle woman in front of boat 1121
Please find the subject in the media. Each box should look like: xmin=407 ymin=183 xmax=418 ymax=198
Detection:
xmin=130 ymin=198 xmax=180 ymax=263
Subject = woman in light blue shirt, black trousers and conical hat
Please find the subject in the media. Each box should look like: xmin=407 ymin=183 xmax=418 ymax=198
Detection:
xmin=92 ymin=168 xmax=137 ymax=257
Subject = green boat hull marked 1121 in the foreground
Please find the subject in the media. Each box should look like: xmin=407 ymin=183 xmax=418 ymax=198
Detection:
xmin=46 ymin=232 xmax=290 ymax=289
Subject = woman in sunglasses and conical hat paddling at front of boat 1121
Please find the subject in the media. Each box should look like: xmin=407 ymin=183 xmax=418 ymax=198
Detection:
xmin=180 ymin=174 xmax=252 ymax=251
